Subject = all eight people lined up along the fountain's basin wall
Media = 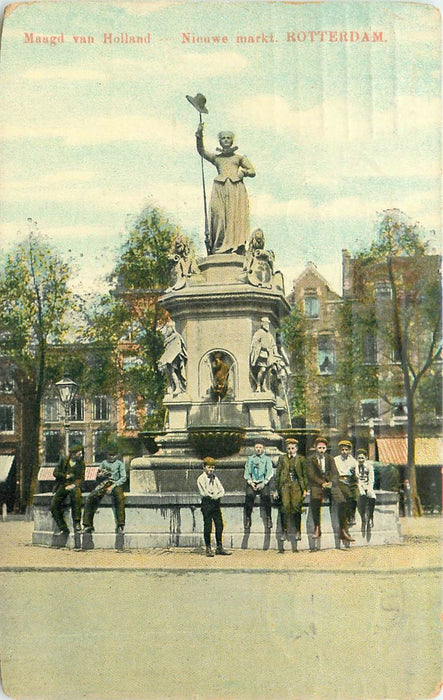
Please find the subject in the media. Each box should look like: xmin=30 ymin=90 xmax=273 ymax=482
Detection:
xmin=51 ymin=437 xmax=375 ymax=557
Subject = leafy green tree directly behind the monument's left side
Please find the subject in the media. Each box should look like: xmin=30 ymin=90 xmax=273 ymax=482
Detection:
xmin=85 ymin=208 xmax=193 ymax=430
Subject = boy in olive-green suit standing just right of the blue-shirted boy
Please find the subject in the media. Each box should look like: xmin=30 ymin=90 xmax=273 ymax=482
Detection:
xmin=275 ymin=438 xmax=308 ymax=541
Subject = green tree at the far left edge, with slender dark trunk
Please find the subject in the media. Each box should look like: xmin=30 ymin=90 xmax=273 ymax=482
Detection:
xmin=0 ymin=220 xmax=72 ymax=510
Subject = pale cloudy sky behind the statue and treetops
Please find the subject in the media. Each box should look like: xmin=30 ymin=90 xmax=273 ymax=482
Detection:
xmin=0 ymin=0 xmax=441 ymax=291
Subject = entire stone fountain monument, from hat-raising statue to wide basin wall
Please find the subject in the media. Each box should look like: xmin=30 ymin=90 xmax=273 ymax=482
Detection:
xmin=33 ymin=94 xmax=400 ymax=549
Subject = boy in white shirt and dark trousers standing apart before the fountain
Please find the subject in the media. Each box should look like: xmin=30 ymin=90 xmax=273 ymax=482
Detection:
xmin=197 ymin=457 xmax=231 ymax=557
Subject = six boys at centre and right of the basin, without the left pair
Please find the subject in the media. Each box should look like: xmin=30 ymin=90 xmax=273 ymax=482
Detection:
xmin=197 ymin=437 xmax=375 ymax=556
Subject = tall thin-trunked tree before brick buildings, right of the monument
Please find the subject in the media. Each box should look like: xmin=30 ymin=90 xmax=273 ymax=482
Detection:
xmin=354 ymin=209 xmax=442 ymax=514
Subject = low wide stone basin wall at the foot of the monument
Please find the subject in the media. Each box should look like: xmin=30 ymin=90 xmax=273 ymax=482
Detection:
xmin=32 ymin=492 xmax=402 ymax=551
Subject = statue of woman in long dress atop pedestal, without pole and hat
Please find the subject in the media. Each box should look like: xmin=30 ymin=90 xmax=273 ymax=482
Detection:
xmin=195 ymin=123 xmax=255 ymax=255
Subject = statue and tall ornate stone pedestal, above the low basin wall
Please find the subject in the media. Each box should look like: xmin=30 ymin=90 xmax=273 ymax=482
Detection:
xmin=131 ymin=94 xmax=290 ymax=493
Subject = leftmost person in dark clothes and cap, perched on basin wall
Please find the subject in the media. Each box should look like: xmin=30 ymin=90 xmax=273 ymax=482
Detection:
xmin=51 ymin=445 xmax=85 ymax=535
